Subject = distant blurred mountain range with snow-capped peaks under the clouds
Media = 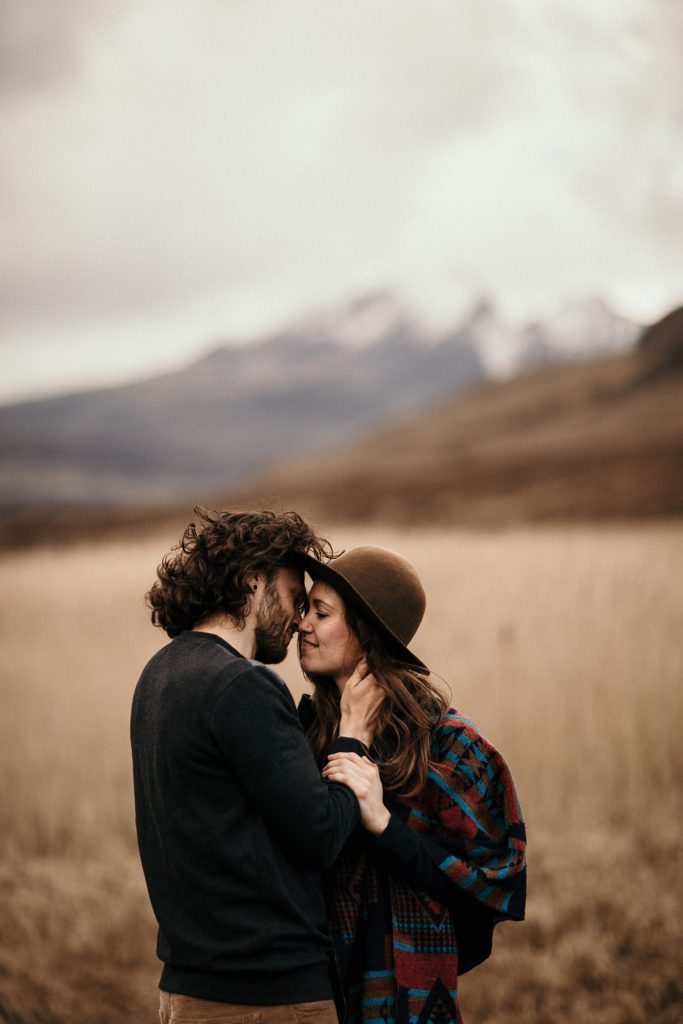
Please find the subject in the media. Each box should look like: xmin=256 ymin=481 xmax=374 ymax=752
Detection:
xmin=0 ymin=291 xmax=638 ymax=506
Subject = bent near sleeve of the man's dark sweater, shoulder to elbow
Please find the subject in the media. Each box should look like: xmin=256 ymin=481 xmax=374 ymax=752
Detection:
xmin=210 ymin=665 xmax=359 ymax=867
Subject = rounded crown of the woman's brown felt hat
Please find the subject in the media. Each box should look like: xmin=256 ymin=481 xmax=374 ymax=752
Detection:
xmin=329 ymin=545 xmax=427 ymax=645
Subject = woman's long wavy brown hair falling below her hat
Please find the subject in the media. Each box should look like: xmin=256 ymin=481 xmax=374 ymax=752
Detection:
xmin=306 ymin=602 xmax=449 ymax=797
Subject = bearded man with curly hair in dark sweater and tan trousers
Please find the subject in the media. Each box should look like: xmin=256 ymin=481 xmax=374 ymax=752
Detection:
xmin=131 ymin=509 xmax=374 ymax=1024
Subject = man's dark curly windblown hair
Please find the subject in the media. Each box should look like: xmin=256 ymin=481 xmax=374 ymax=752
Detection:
xmin=145 ymin=507 xmax=334 ymax=637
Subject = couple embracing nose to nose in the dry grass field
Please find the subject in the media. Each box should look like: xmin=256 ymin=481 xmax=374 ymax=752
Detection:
xmin=131 ymin=510 xmax=525 ymax=1024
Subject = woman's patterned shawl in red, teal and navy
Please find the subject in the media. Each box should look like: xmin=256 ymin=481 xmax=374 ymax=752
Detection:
xmin=329 ymin=710 xmax=526 ymax=1024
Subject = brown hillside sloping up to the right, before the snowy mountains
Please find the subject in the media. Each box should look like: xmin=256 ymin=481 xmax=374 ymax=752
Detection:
xmin=227 ymin=309 xmax=683 ymax=523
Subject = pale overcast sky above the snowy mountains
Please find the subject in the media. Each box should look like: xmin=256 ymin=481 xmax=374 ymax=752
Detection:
xmin=0 ymin=0 xmax=683 ymax=400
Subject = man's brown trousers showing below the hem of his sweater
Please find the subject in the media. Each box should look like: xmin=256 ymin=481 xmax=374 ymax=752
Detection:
xmin=159 ymin=991 xmax=337 ymax=1024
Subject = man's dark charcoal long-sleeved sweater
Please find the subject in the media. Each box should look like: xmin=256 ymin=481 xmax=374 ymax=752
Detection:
xmin=131 ymin=632 xmax=361 ymax=1005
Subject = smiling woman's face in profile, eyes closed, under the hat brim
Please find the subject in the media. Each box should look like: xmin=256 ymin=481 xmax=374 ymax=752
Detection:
xmin=299 ymin=580 xmax=362 ymax=689
